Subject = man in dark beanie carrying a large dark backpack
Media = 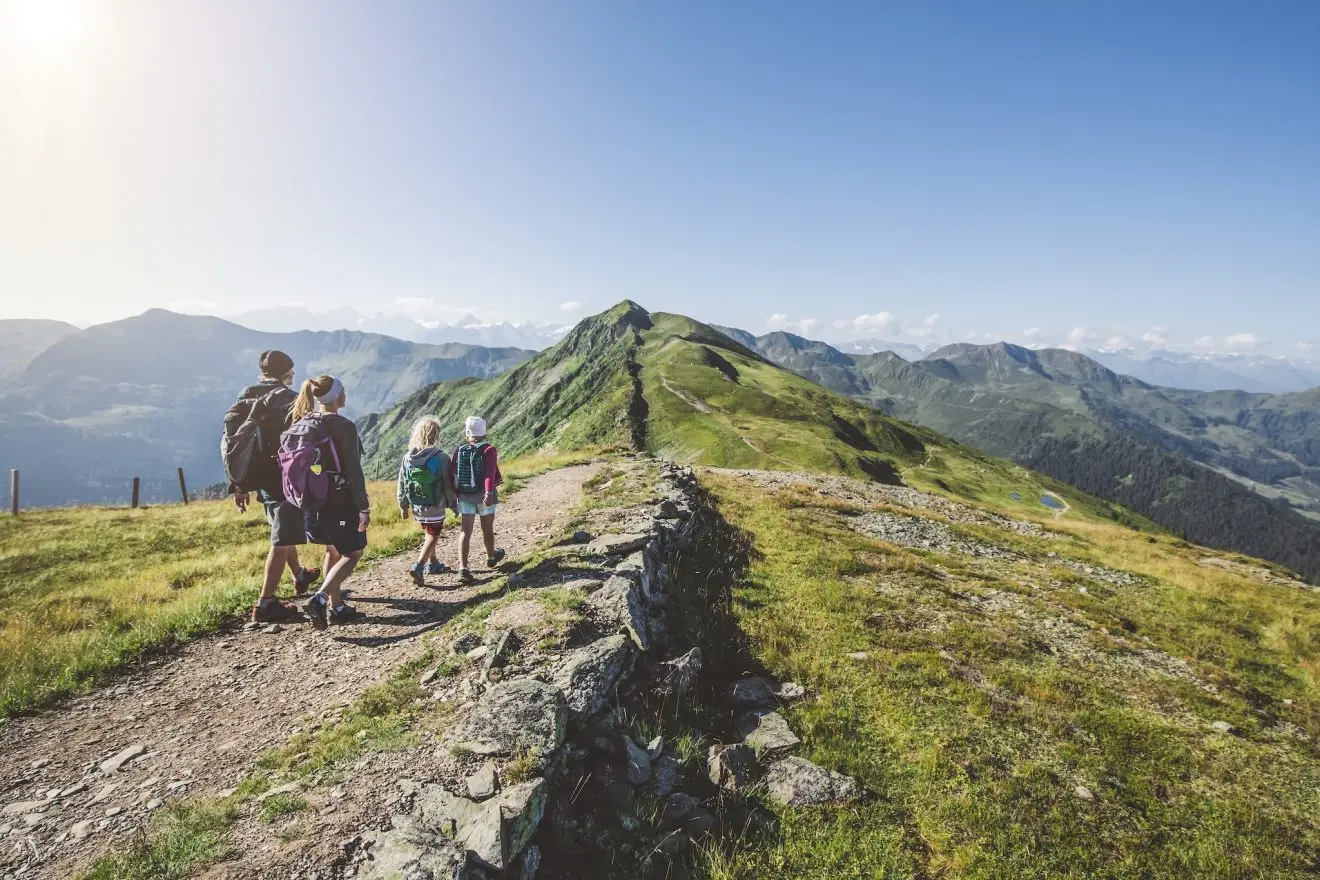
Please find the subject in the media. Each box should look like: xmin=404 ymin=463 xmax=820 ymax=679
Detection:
xmin=220 ymin=350 xmax=321 ymax=623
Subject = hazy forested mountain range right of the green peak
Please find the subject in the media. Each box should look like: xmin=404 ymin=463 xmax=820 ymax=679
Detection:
xmin=737 ymin=332 xmax=1320 ymax=571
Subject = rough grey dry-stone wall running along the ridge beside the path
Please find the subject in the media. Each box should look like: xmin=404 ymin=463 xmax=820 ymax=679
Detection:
xmin=347 ymin=464 xmax=701 ymax=880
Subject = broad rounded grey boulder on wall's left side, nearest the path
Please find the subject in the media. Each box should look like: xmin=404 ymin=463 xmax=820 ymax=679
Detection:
xmin=442 ymin=678 xmax=568 ymax=767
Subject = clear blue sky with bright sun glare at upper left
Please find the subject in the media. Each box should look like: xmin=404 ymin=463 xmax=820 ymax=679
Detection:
xmin=0 ymin=0 xmax=1320 ymax=352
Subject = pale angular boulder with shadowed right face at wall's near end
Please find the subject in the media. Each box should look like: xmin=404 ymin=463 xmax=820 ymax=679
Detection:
xmin=414 ymin=778 xmax=549 ymax=871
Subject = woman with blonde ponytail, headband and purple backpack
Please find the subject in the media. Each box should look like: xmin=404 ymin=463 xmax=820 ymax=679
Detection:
xmin=280 ymin=376 xmax=371 ymax=629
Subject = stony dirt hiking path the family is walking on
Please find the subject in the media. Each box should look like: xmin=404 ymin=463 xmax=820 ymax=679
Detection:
xmin=0 ymin=466 xmax=598 ymax=880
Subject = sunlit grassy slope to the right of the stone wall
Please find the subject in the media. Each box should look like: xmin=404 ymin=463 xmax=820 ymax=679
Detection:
xmin=704 ymin=475 xmax=1320 ymax=880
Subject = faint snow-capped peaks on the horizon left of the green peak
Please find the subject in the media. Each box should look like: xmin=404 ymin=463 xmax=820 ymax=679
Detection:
xmin=228 ymin=306 xmax=569 ymax=351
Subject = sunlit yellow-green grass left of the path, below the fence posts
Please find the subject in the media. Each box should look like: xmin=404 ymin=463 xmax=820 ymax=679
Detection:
xmin=0 ymin=456 xmax=579 ymax=718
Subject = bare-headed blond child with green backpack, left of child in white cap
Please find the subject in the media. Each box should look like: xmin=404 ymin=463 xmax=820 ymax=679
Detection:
xmin=395 ymin=416 xmax=458 ymax=587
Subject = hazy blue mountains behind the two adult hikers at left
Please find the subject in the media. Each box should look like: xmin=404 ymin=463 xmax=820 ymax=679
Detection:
xmin=0 ymin=310 xmax=535 ymax=505
